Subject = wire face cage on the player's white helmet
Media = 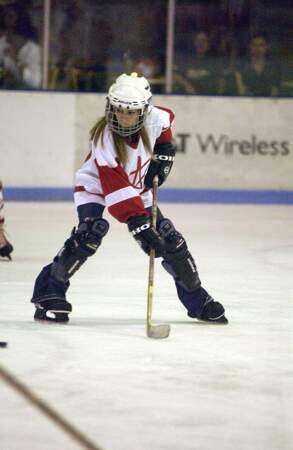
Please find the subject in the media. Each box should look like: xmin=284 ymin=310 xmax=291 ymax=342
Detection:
xmin=105 ymin=99 xmax=147 ymax=137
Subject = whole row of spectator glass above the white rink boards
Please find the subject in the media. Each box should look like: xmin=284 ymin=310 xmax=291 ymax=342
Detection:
xmin=0 ymin=0 xmax=293 ymax=97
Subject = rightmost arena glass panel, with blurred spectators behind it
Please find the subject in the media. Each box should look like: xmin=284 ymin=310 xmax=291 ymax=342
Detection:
xmin=172 ymin=0 xmax=293 ymax=97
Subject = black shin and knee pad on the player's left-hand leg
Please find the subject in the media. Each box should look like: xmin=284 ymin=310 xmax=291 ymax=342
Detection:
xmin=51 ymin=218 xmax=109 ymax=283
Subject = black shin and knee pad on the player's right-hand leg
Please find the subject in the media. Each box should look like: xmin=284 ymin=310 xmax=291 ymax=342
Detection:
xmin=159 ymin=219 xmax=201 ymax=291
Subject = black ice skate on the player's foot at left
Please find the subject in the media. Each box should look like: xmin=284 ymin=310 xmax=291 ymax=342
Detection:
xmin=34 ymin=299 xmax=72 ymax=323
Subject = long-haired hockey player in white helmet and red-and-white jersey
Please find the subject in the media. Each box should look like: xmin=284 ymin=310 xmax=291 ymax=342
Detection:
xmin=31 ymin=73 xmax=228 ymax=323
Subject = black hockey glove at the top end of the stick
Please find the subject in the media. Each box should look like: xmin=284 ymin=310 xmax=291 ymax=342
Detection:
xmin=144 ymin=142 xmax=176 ymax=188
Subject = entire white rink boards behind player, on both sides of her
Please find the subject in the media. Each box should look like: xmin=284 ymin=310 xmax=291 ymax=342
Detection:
xmin=0 ymin=92 xmax=293 ymax=190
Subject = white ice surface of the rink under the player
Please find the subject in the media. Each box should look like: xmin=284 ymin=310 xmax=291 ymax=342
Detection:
xmin=0 ymin=203 xmax=293 ymax=450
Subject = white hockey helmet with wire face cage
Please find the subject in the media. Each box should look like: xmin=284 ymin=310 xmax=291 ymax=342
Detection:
xmin=105 ymin=72 xmax=152 ymax=136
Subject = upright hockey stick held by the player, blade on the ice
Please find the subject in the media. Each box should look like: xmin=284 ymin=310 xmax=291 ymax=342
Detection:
xmin=147 ymin=176 xmax=170 ymax=339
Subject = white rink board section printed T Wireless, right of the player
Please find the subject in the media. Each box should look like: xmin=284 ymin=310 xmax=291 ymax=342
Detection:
xmin=157 ymin=97 xmax=293 ymax=190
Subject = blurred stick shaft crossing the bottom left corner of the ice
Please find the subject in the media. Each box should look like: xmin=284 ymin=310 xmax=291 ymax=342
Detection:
xmin=0 ymin=365 xmax=102 ymax=450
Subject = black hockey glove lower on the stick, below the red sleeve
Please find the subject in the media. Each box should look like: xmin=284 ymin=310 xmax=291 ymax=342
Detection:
xmin=128 ymin=216 xmax=164 ymax=258
